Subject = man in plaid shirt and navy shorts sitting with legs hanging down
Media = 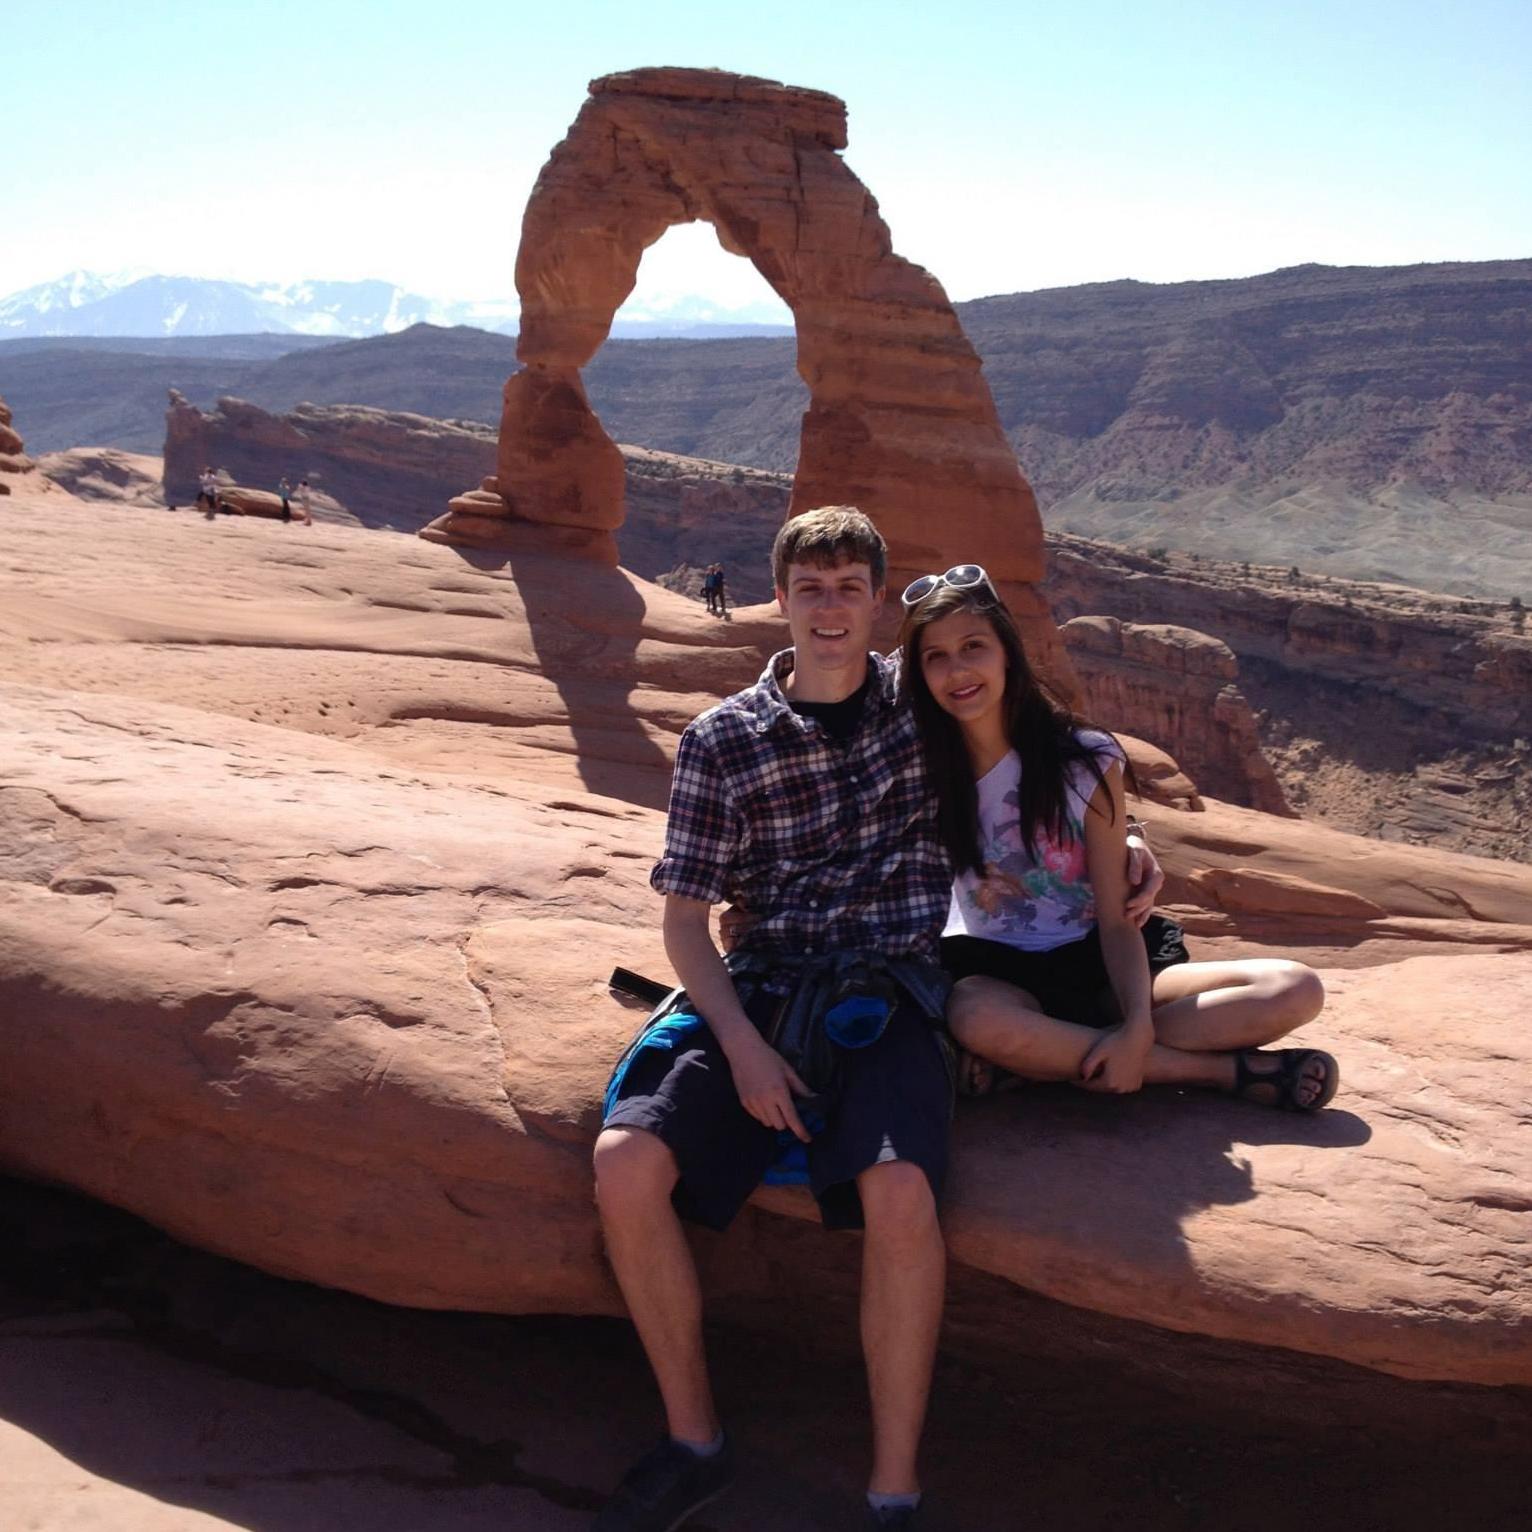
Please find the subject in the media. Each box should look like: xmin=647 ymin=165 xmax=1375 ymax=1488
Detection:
xmin=594 ymin=507 xmax=951 ymax=1532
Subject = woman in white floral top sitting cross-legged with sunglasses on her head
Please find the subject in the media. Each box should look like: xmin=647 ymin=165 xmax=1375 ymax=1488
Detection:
xmin=902 ymin=564 xmax=1339 ymax=1112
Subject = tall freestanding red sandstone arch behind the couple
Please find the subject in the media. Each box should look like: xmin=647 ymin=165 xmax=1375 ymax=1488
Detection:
xmin=424 ymin=69 xmax=1057 ymax=654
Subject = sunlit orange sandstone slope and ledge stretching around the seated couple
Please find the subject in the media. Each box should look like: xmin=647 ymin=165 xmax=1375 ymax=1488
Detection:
xmin=0 ymin=492 xmax=1532 ymax=1397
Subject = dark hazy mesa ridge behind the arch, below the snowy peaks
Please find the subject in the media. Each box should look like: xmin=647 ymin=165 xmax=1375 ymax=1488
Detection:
xmin=0 ymin=260 xmax=1532 ymax=601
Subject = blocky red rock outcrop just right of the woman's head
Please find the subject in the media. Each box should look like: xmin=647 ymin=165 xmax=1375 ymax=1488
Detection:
xmin=1059 ymin=617 xmax=1293 ymax=815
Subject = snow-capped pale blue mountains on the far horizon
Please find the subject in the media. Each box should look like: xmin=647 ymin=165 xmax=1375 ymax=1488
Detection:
xmin=0 ymin=271 xmax=792 ymax=339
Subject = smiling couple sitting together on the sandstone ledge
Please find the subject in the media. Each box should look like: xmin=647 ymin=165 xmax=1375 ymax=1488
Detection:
xmin=593 ymin=506 xmax=1339 ymax=1532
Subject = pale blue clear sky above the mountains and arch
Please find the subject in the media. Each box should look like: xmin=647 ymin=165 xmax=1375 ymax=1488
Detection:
xmin=0 ymin=0 xmax=1532 ymax=315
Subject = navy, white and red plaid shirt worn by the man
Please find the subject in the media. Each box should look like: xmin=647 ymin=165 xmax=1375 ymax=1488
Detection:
xmin=650 ymin=650 xmax=951 ymax=961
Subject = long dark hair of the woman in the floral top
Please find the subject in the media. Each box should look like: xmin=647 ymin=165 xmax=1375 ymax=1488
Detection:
xmin=899 ymin=585 xmax=1115 ymax=873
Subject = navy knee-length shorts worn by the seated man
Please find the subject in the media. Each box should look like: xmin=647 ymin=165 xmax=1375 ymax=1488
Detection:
xmin=605 ymin=993 xmax=953 ymax=1229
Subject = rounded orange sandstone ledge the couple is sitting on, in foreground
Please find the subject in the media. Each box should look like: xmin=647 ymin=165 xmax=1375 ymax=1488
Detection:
xmin=0 ymin=688 xmax=1532 ymax=1383
